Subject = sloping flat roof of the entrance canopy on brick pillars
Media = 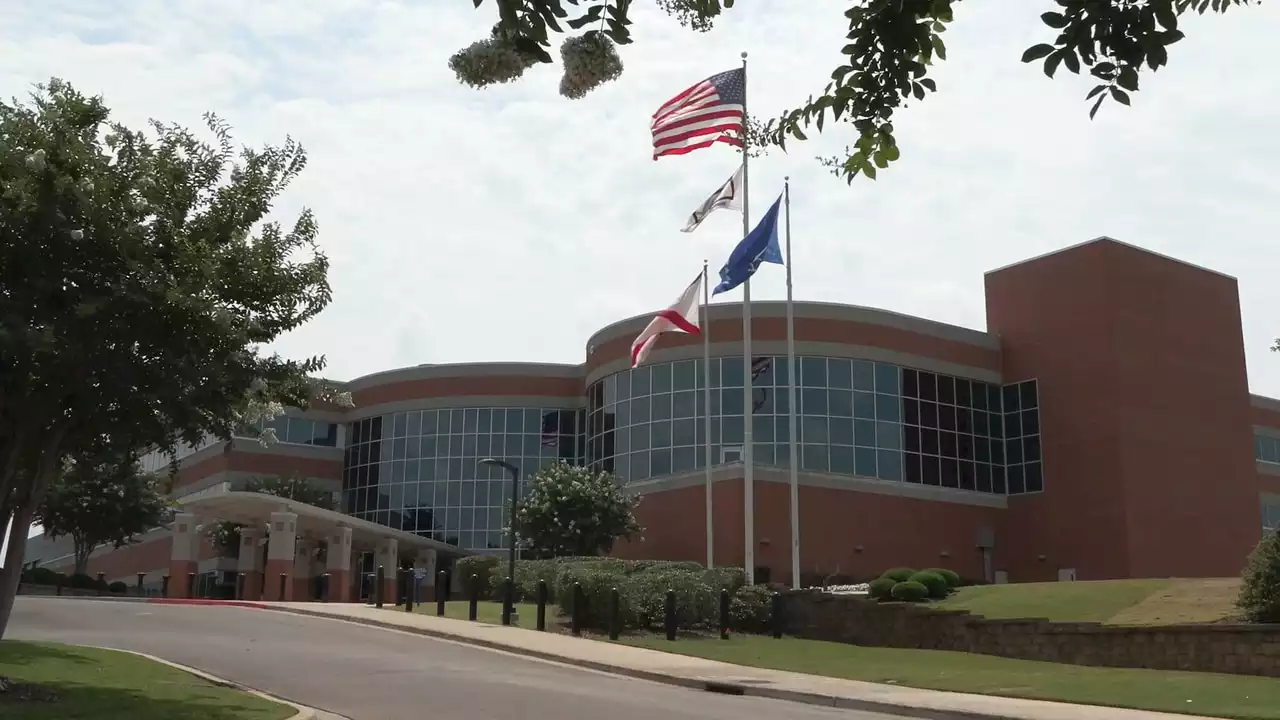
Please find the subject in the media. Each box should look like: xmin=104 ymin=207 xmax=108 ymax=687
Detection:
xmin=178 ymin=483 xmax=472 ymax=557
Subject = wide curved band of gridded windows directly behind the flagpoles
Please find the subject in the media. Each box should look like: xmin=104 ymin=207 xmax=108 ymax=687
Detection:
xmin=586 ymin=356 xmax=1043 ymax=493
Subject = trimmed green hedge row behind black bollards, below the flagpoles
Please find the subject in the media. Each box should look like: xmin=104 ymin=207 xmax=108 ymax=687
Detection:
xmin=454 ymin=556 xmax=772 ymax=632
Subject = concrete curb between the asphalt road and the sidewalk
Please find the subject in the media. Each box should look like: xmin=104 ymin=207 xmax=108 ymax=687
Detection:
xmin=251 ymin=605 xmax=1039 ymax=720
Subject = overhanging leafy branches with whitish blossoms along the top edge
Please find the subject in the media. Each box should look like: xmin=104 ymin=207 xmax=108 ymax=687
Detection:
xmin=449 ymin=0 xmax=1261 ymax=182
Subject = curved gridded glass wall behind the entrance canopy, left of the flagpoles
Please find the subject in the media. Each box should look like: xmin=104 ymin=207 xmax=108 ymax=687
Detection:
xmin=343 ymin=407 xmax=584 ymax=550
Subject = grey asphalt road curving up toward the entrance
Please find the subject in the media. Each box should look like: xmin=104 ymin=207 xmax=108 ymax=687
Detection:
xmin=6 ymin=597 xmax=891 ymax=720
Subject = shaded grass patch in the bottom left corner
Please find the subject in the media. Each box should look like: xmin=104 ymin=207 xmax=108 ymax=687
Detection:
xmin=0 ymin=641 xmax=297 ymax=720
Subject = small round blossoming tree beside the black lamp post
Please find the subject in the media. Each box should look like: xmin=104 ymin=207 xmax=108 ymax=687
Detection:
xmin=516 ymin=462 xmax=641 ymax=557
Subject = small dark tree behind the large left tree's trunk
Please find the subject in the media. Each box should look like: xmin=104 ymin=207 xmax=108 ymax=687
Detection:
xmin=35 ymin=448 xmax=166 ymax=575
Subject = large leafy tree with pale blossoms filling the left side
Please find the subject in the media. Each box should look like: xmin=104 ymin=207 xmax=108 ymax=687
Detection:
xmin=0 ymin=79 xmax=349 ymax=637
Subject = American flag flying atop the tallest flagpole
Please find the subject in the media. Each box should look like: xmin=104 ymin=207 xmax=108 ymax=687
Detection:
xmin=650 ymin=68 xmax=746 ymax=160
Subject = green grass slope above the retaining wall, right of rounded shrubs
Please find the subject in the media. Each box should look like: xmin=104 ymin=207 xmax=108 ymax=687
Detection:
xmin=934 ymin=579 xmax=1177 ymax=624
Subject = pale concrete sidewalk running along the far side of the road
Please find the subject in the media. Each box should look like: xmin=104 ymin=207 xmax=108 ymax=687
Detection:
xmin=244 ymin=602 xmax=1218 ymax=720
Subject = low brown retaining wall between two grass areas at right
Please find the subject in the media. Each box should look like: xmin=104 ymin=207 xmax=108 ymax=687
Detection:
xmin=786 ymin=592 xmax=1280 ymax=678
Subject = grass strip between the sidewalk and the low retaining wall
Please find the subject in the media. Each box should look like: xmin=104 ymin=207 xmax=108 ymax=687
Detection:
xmin=621 ymin=635 xmax=1280 ymax=720
